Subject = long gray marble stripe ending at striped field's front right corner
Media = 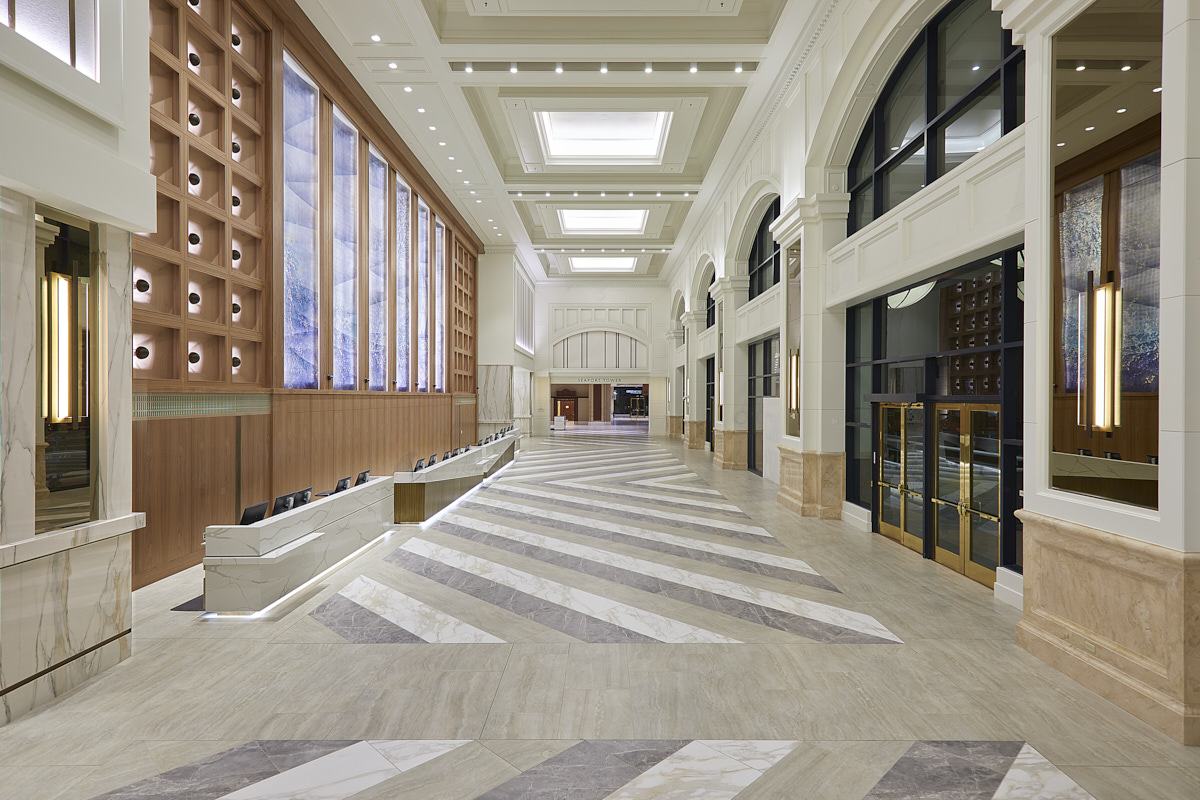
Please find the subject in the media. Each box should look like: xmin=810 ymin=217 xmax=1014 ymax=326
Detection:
xmin=436 ymin=522 xmax=896 ymax=644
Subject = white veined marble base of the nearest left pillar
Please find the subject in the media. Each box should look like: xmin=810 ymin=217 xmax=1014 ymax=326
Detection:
xmin=0 ymin=534 xmax=133 ymax=724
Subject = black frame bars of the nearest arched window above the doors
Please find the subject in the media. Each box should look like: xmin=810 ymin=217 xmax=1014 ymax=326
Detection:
xmin=846 ymin=0 xmax=1025 ymax=235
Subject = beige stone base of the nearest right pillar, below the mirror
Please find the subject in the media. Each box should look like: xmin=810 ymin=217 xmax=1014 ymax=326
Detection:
xmin=1016 ymin=511 xmax=1200 ymax=745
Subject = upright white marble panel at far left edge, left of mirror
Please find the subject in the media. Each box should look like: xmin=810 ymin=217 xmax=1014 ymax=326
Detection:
xmin=0 ymin=188 xmax=41 ymax=543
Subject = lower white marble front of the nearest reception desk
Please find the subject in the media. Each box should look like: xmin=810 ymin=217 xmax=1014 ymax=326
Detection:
xmin=204 ymin=494 xmax=394 ymax=614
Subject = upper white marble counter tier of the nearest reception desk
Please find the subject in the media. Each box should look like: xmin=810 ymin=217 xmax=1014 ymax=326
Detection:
xmin=204 ymin=476 xmax=392 ymax=564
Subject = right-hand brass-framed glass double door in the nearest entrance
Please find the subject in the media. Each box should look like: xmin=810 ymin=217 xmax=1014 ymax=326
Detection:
xmin=932 ymin=404 xmax=1001 ymax=587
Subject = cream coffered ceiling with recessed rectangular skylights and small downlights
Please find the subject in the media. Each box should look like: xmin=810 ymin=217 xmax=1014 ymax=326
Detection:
xmin=299 ymin=0 xmax=833 ymax=281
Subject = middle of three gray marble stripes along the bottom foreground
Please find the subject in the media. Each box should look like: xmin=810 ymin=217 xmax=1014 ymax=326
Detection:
xmin=475 ymin=740 xmax=700 ymax=800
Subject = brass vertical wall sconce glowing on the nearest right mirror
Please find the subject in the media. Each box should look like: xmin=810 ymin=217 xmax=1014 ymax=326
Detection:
xmin=1079 ymin=272 xmax=1122 ymax=435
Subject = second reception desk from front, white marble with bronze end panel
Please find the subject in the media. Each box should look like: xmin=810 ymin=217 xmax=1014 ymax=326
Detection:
xmin=394 ymin=431 xmax=521 ymax=524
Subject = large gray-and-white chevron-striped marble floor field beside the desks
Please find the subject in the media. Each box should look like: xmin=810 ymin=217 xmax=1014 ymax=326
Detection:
xmin=312 ymin=432 xmax=900 ymax=644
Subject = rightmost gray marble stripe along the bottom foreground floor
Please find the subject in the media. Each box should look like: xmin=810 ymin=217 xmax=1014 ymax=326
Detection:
xmin=863 ymin=741 xmax=1025 ymax=800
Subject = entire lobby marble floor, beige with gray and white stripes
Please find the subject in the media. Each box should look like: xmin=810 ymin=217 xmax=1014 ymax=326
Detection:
xmin=0 ymin=426 xmax=1200 ymax=800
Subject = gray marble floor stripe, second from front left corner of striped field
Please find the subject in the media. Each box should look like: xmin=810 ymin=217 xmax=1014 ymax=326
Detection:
xmin=384 ymin=549 xmax=658 ymax=644
